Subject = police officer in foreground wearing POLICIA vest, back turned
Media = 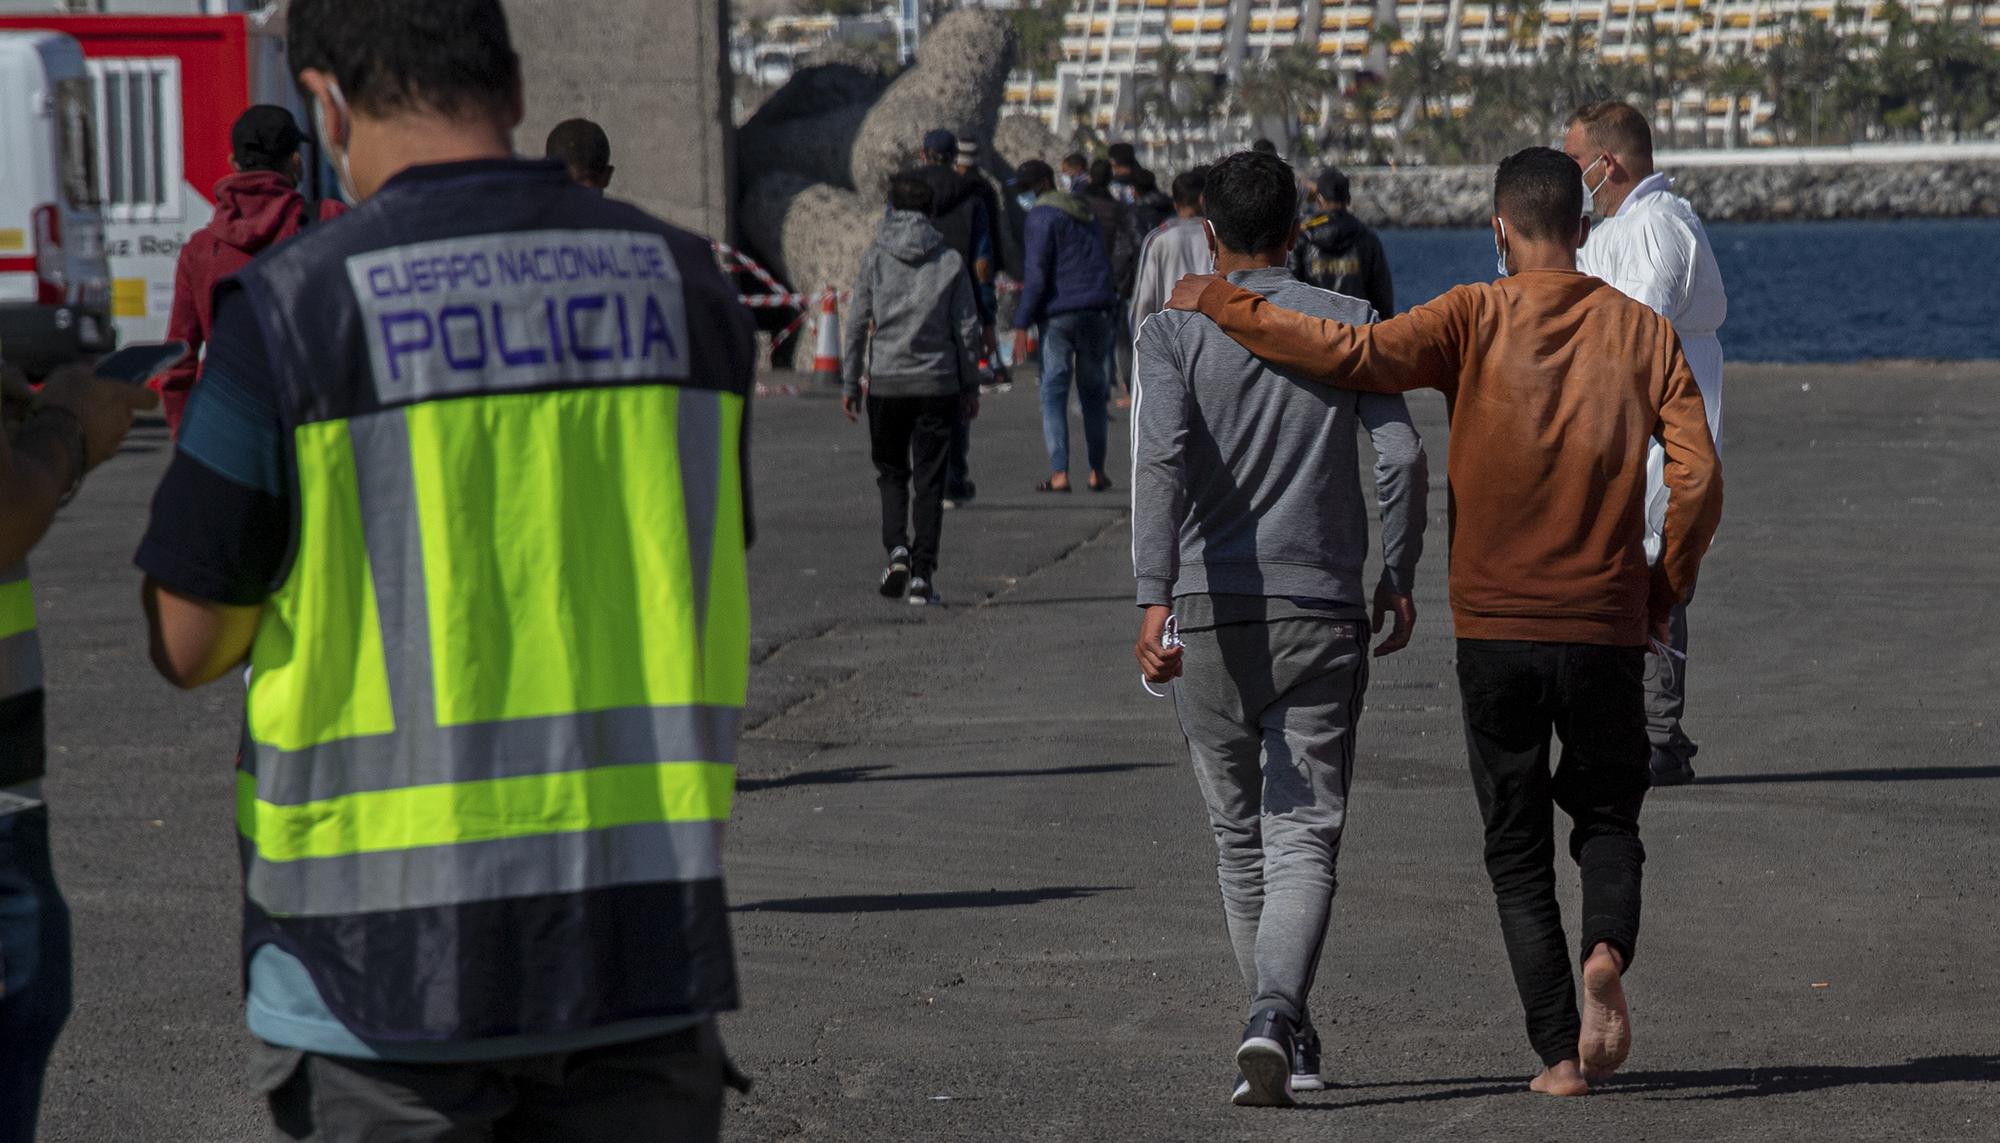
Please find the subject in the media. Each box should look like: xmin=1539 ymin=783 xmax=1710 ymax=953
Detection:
xmin=138 ymin=0 xmax=752 ymax=1143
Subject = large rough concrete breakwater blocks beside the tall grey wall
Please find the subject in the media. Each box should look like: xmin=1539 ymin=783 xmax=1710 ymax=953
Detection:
xmin=736 ymin=8 xmax=1056 ymax=294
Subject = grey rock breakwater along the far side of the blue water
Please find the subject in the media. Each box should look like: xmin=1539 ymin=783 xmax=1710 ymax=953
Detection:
xmin=1350 ymin=160 xmax=2000 ymax=228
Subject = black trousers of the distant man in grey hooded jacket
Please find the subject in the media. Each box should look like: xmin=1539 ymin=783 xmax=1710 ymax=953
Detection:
xmin=868 ymin=396 xmax=958 ymax=579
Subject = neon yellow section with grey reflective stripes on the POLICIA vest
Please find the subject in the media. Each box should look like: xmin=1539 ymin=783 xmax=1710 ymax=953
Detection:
xmin=238 ymin=386 xmax=748 ymax=917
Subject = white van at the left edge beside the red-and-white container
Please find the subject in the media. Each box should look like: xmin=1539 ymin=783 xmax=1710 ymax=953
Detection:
xmin=0 ymin=32 xmax=114 ymax=376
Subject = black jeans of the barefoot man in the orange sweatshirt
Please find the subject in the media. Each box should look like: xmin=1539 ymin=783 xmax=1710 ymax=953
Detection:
xmin=1458 ymin=639 xmax=1650 ymax=1063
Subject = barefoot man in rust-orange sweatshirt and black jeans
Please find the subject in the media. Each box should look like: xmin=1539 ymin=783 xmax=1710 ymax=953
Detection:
xmin=1170 ymin=148 xmax=1722 ymax=1095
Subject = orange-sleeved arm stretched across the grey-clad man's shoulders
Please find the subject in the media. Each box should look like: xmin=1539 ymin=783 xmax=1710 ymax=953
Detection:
xmin=1174 ymin=278 xmax=1472 ymax=394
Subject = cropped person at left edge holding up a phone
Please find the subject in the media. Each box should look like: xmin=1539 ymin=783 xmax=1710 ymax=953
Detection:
xmin=0 ymin=364 xmax=160 ymax=1143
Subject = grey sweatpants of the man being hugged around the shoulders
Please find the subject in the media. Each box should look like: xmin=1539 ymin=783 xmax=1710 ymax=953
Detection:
xmin=1174 ymin=617 xmax=1368 ymax=1023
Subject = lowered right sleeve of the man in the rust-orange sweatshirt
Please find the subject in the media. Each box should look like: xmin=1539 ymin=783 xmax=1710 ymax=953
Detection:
xmin=1652 ymin=335 xmax=1722 ymax=621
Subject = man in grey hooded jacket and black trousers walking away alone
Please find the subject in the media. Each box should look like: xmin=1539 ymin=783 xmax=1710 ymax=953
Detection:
xmin=840 ymin=174 xmax=984 ymax=605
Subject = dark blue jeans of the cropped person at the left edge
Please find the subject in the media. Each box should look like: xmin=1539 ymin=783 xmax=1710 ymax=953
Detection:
xmin=0 ymin=807 xmax=70 ymax=1143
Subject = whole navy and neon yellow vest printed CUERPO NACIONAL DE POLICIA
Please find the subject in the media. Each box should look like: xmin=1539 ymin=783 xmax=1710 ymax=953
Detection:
xmin=236 ymin=162 xmax=750 ymax=1041
